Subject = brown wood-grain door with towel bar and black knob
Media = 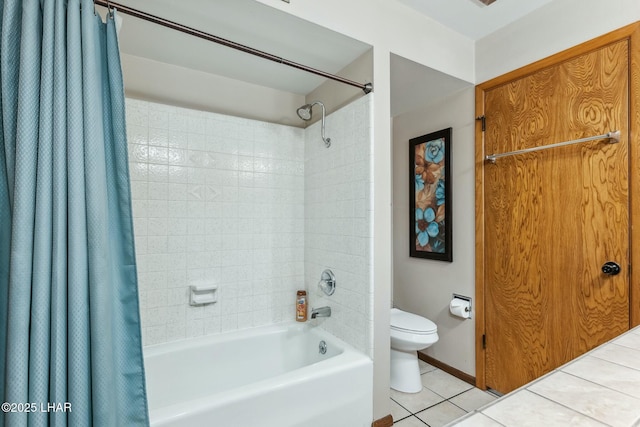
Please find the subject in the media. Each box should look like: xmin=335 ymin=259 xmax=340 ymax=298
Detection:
xmin=483 ymin=41 xmax=629 ymax=393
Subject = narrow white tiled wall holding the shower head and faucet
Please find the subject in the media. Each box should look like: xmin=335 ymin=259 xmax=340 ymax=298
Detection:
xmin=304 ymin=96 xmax=373 ymax=356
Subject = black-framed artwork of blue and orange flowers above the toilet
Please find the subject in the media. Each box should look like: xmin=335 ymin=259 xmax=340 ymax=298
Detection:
xmin=409 ymin=128 xmax=453 ymax=262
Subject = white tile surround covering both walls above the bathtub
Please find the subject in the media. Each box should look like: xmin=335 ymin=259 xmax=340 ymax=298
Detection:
xmin=127 ymin=96 xmax=373 ymax=355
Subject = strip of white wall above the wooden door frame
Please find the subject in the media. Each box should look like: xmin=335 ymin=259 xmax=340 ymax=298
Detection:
xmin=475 ymin=0 xmax=640 ymax=83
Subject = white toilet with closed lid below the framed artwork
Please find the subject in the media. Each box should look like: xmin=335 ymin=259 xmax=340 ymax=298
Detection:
xmin=391 ymin=308 xmax=438 ymax=393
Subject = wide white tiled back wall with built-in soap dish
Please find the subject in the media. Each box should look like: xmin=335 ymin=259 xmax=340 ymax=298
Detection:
xmin=127 ymin=99 xmax=304 ymax=345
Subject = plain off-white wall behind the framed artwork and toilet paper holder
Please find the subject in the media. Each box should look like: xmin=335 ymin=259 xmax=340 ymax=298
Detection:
xmin=393 ymin=87 xmax=475 ymax=375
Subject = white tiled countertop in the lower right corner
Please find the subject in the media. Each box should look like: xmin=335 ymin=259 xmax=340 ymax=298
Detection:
xmin=448 ymin=326 xmax=640 ymax=427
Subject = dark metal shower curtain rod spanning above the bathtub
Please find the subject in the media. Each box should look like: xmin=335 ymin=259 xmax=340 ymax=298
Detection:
xmin=93 ymin=0 xmax=373 ymax=94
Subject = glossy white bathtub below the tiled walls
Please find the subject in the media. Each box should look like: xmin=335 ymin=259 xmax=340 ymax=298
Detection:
xmin=144 ymin=323 xmax=373 ymax=427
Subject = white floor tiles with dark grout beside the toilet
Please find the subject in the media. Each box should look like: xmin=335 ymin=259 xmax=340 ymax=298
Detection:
xmin=391 ymin=360 xmax=496 ymax=427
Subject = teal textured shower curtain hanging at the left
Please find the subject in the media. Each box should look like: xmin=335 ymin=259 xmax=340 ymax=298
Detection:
xmin=0 ymin=0 xmax=149 ymax=427
